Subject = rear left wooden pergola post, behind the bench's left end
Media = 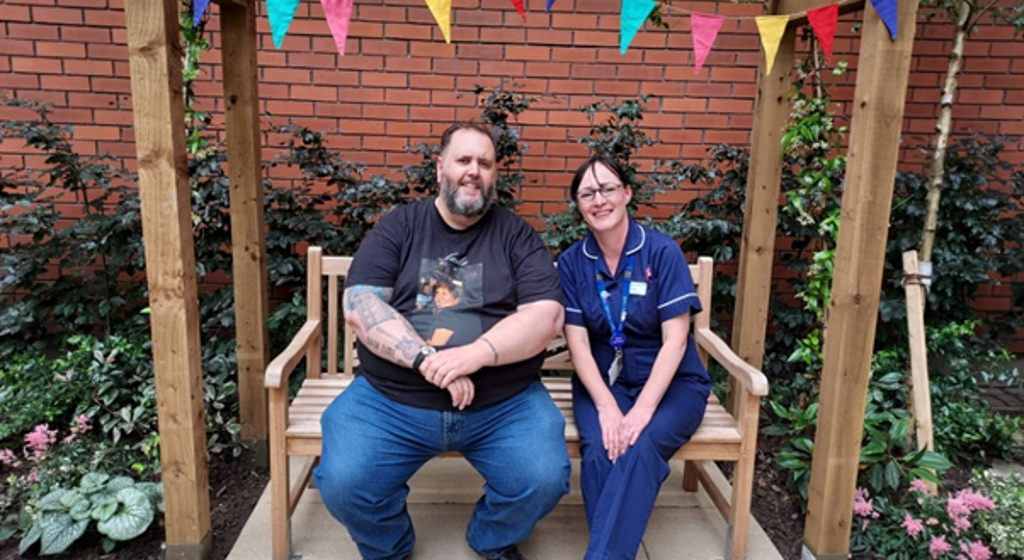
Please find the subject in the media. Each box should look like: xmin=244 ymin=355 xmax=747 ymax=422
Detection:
xmin=220 ymin=2 xmax=269 ymax=464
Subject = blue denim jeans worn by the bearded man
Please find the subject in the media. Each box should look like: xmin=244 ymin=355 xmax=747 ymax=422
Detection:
xmin=313 ymin=377 xmax=570 ymax=560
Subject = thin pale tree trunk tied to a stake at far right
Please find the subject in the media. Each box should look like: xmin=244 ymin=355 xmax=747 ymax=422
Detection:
xmin=921 ymin=0 xmax=972 ymax=263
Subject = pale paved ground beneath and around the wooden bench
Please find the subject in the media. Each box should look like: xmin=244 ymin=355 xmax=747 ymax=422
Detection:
xmin=227 ymin=458 xmax=782 ymax=560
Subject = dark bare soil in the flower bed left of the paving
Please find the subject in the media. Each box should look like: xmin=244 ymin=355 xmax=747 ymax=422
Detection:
xmin=0 ymin=453 xmax=270 ymax=560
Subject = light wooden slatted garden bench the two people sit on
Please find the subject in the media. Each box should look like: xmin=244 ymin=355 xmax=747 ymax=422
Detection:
xmin=264 ymin=247 xmax=768 ymax=560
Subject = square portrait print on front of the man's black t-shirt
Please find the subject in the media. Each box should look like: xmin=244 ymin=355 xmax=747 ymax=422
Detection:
xmin=411 ymin=254 xmax=483 ymax=346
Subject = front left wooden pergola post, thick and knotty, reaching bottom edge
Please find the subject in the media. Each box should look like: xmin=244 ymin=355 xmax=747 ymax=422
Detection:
xmin=125 ymin=0 xmax=210 ymax=558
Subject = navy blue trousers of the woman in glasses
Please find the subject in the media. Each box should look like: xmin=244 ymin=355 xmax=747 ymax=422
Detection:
xmin=572 ymin=378 xmax=711 ymax=560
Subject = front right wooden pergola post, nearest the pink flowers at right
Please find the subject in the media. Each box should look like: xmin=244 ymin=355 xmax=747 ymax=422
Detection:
xmin=804 ymin=2 xmax=918 ymax=559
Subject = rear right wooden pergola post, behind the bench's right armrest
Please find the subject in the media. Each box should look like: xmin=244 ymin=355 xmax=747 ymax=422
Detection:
xmin=728 ymin=13 xmax=797 ymax=395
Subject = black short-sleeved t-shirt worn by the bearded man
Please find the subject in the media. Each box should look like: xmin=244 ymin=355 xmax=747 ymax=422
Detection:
xmin=345 ymin=199 xmax=562 ymax=411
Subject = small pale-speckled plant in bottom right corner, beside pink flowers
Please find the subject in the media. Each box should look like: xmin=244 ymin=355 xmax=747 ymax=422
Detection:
xmin=971 ymin=471 xmax=1024 ymax=558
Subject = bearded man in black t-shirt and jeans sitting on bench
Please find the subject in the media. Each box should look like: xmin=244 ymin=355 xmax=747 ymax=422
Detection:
xmin=314 ymin=123 xmax=570 ymax=560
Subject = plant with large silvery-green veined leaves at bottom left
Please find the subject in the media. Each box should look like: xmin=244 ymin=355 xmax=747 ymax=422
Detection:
xmin=18 ymin=472 xmax=164 ymax=555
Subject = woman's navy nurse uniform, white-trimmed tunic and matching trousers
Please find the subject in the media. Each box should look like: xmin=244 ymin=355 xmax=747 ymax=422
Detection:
xmin=558 ymin=221 xmax=711 ymax=560
